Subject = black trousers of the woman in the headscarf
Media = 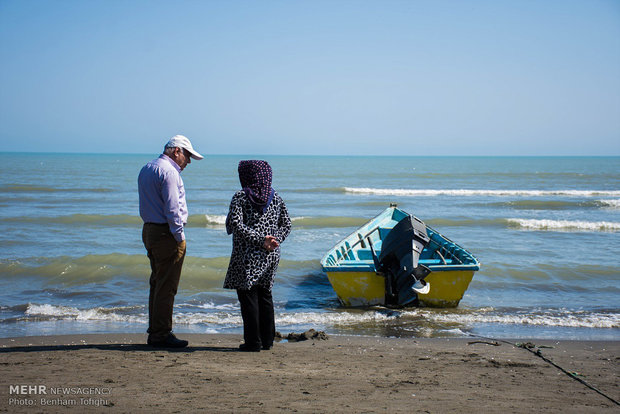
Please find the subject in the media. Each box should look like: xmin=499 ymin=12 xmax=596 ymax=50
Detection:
xmin=237 ymin=286 xmax=276 ymax=347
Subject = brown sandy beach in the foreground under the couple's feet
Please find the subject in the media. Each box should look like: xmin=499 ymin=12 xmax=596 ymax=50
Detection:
xmin=0 ymin=334 xmax=620 ymax=413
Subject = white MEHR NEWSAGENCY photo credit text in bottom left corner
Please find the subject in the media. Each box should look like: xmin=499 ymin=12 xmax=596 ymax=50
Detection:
xmin=8 ymin=384 xmax=114 ymax=407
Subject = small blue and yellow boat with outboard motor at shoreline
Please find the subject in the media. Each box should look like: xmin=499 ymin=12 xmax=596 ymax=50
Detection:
xmin=321 ymin=204 xmax=480 ymax=308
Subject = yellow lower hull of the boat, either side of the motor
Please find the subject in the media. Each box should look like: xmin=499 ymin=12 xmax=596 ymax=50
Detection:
xmin=327 ymin=270 xmax=474 ymax=308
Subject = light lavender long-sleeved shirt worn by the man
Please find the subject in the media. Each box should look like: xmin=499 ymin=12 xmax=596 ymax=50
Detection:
xmin=138 ymin=154 xmax=188 ymax=242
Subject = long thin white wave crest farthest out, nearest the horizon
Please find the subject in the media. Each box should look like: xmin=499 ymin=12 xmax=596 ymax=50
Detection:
xmin=343 ymin=187 xmax=620 ymax=197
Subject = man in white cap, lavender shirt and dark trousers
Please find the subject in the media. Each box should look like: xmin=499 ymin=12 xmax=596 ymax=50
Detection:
xmin=138 ymin=135 xmax=203 ymax=348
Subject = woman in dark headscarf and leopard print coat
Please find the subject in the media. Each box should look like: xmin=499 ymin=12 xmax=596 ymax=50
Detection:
xmin=224 ymin=160 xmax=291 ymax=352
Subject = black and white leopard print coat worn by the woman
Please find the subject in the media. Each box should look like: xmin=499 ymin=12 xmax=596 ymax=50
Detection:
xmin=224 ymin=191 xmax=291 ymax=290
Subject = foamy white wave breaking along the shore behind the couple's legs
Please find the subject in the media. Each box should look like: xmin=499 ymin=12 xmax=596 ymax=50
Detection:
xmin=13 ymin=304 xmax=620 ymax=329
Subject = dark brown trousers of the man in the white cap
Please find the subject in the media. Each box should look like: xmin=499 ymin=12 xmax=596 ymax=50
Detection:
xmin=142 ymin=223 xmax=185 ymax=341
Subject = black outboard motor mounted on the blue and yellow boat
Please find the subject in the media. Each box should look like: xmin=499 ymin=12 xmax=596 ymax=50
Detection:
xmin=379 ymin=216 xmax=431 ymax=306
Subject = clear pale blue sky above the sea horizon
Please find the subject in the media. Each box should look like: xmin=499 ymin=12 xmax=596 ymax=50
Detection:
xmin=0 ymin=0 xmax=620 ymax=155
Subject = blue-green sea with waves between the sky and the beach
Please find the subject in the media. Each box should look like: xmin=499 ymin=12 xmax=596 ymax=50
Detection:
xmin=0 ymin=153 xmax=620 ymax=340
